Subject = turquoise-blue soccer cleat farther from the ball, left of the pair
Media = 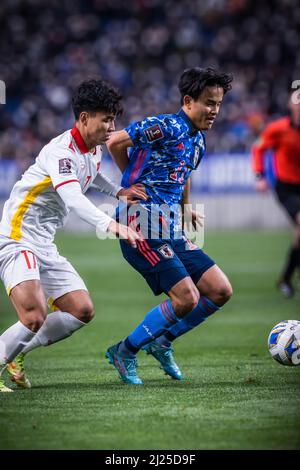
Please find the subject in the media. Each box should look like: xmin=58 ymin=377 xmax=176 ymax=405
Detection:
xmin=105 ymin=343 xmax=143 ymax=385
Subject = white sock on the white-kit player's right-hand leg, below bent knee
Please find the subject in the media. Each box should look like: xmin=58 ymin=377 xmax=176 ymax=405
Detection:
xmin=22 ymin=310 xmax=86 ymax=353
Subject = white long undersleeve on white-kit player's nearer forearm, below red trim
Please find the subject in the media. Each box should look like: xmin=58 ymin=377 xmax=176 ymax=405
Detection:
xmin=57 ymin=181 xmax=113 ymax=232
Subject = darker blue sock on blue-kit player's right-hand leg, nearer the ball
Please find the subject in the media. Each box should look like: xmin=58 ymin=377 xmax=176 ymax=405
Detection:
xmin=157 ymin=297 xmax=220 ymax=346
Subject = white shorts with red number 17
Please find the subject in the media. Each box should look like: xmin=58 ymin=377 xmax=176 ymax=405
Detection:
xmin=0 ymin=235 xmax=87 ymax=306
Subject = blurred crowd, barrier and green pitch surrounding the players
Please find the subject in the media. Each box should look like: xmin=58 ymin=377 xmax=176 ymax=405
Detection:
xmin=0 ymin=0 xmax=300 ymax=449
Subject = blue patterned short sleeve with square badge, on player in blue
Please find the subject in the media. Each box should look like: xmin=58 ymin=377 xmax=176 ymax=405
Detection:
xmin=125 ymin=116 xmax=174 ymax=148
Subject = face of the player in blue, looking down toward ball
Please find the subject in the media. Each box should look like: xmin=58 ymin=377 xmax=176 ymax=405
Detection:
xmin=185 ymin=86 xmax=224 ymax=130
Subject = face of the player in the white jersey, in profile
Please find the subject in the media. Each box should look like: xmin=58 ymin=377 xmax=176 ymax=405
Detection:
xmin=86 ymin=111 xmax=115 ymax=145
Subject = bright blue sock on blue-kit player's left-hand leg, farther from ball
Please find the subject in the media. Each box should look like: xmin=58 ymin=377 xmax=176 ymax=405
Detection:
xmin=118 ymin=299 xmax=178 ymax=357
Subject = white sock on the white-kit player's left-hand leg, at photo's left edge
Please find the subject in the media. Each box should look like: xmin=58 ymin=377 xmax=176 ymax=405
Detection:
xmin=0 ymin=321 xmax=36 ymax=366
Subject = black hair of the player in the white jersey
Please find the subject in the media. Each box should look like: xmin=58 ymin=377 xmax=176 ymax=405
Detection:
xmin=72 ymin=79 xmax=123 ymax=121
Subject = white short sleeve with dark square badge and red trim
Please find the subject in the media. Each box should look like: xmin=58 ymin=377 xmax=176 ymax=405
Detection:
xmin=45 ymin=146 xmax=79 ymax=189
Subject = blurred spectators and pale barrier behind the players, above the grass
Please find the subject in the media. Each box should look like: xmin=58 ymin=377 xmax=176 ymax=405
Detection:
xmin=0 ymin=0 xmax=300 ymax=228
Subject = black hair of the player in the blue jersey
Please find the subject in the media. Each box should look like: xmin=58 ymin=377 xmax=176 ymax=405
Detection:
xmin=178 ymin=67 xmax=233 ymax=104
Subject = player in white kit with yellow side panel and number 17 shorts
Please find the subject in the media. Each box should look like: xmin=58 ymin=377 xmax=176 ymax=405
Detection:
xmin=0 ymin=80 xmax=147 ymax=392
